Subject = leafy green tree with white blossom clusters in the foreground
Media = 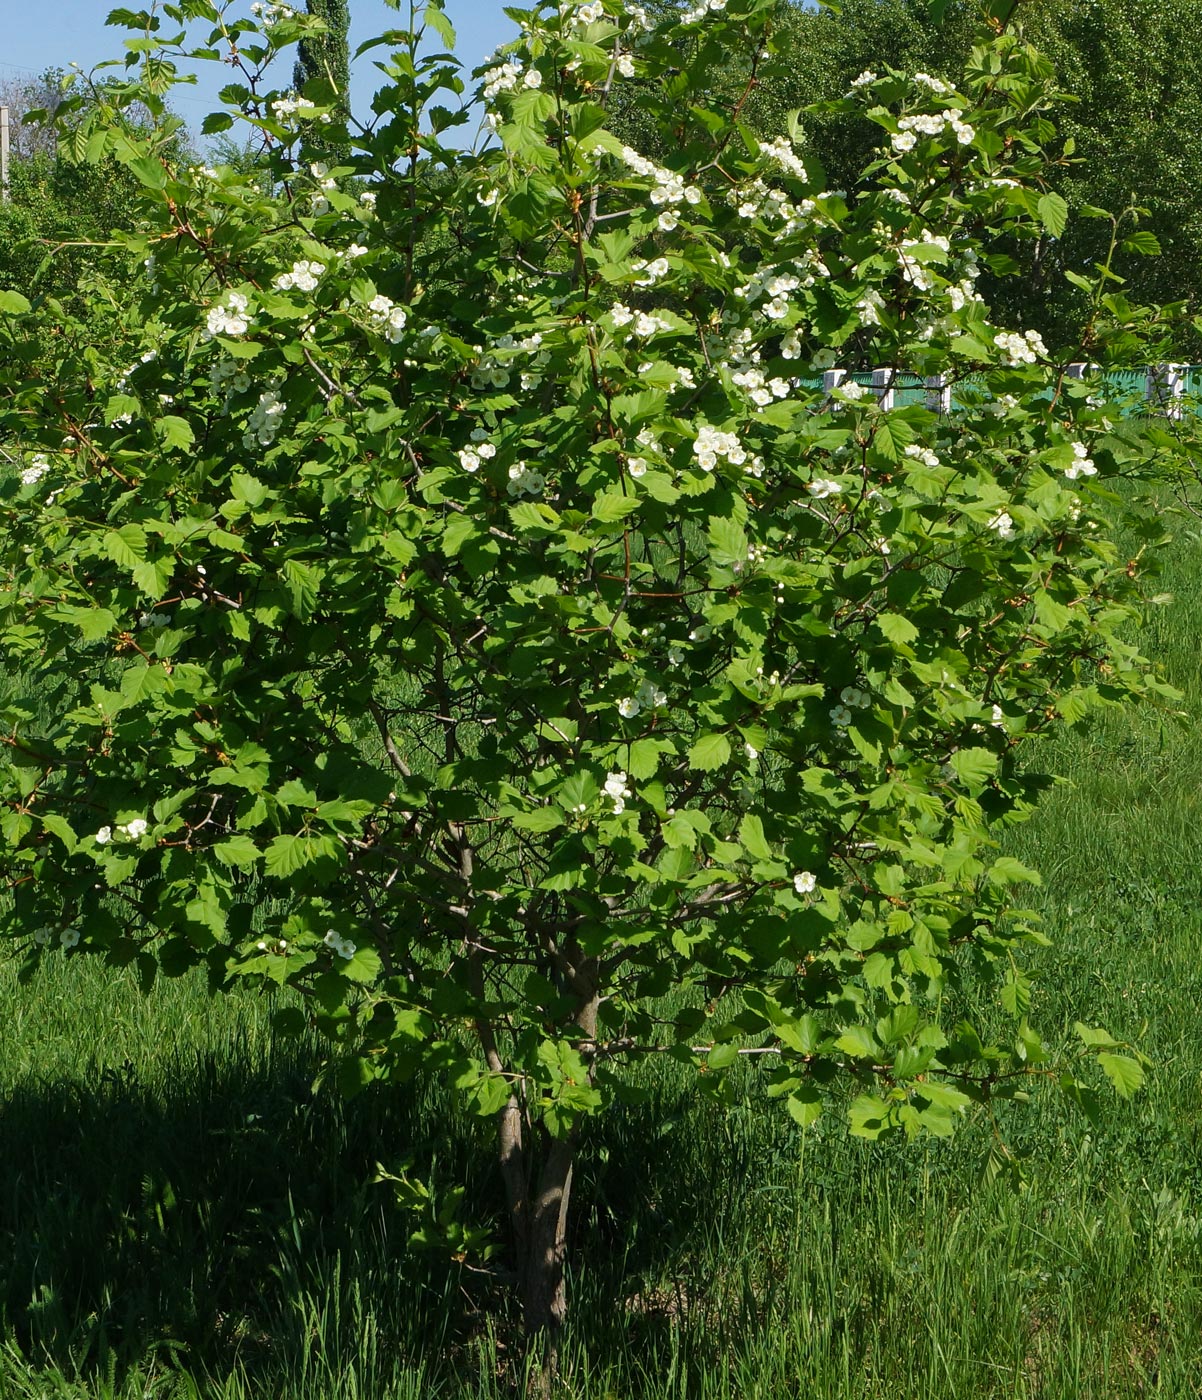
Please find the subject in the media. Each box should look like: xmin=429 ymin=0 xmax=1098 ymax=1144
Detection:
xmin=0 ymin=0 xmax=1186 ymax=1360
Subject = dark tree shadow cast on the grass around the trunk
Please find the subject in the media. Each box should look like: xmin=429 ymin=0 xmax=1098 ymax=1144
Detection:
xmin=0 ymin=1046 xmax=800 ymax=1394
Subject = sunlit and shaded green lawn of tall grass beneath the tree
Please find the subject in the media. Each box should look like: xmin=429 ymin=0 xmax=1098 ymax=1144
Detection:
xmin=0 ymin=518 xmax=1202 ymax=1400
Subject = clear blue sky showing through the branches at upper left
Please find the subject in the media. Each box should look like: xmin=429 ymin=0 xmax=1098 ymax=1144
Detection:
xmin=0 ymin=0 xmax=516 ymax=127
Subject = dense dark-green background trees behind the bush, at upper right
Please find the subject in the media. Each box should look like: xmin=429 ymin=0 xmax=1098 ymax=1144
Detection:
xmin=765 ymin=0 xmax=1202 ymax=358
